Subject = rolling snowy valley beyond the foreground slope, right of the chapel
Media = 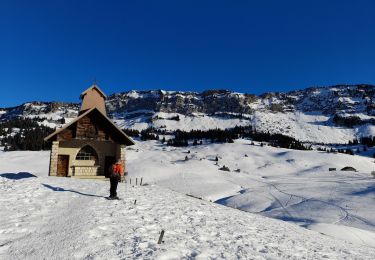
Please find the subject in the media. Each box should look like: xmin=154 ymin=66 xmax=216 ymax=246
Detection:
xmin=128 ymin=140 xmax=375 ymax=247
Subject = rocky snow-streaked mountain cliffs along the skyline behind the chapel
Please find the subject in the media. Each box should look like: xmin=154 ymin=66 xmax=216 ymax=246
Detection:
xmin=0 ymin=85 xmax=375 ymax=143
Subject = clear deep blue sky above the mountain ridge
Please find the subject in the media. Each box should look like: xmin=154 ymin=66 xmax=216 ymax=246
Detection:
xmin=0 ymin=0 xmax=375 ymax=107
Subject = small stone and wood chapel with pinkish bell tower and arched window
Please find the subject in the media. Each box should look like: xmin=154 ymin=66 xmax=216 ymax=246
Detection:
xmin=44 ymin=84 xmax=134 ymax=178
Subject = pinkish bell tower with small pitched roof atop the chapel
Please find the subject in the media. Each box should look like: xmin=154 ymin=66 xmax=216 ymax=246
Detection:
xmin=79 ymin=83 xmax=107 ymax=115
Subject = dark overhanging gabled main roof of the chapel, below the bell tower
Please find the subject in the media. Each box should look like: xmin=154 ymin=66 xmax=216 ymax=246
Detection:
xmin=44 ymin=107 xmax=135 ymax=146
